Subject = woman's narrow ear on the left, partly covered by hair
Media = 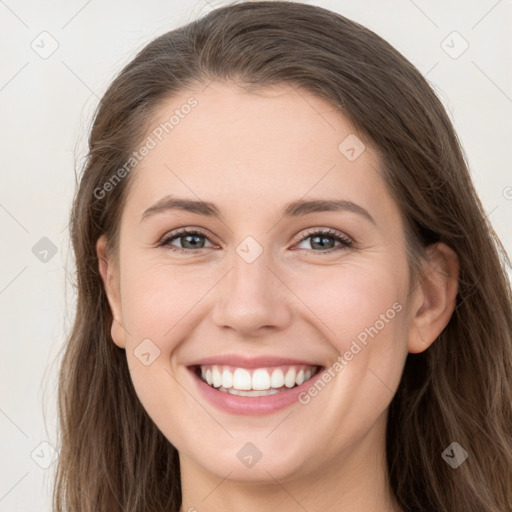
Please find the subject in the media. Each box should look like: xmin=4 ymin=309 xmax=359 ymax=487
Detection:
xmin=96 ymin=235 xmax=126 ymax=348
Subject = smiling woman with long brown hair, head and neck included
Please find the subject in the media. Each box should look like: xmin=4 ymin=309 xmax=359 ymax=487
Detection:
xmin=54 ymin=2 xmax=512 ymax=512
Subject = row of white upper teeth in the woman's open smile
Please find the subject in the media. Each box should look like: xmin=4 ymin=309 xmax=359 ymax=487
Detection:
xmin=201 ymin=365 xmax=318 ymax=396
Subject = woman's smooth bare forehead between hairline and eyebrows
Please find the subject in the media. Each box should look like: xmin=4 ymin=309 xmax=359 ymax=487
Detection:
xmin=124 ymin=82 xmax=393 ymax=222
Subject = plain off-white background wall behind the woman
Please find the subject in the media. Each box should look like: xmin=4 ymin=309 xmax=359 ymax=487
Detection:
xmin=0 ymin=0 xmax=512 ymax=512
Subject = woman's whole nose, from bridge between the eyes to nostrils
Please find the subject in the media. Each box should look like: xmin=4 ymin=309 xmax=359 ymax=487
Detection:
xmin=214 ymin=237 xmax=290 ymax=334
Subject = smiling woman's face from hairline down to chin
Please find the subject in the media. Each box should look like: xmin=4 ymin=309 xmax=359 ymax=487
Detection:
xmin=97 ymin=82 xmax=440 ymax=481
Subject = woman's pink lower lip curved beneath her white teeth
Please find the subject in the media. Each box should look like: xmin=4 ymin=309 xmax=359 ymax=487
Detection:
xmin=188 ymin=368 xmax=323 ymax=416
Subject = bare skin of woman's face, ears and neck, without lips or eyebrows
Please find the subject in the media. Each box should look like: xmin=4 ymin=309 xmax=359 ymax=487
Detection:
xmin=97 ymin=82 xmax=458 ymax=512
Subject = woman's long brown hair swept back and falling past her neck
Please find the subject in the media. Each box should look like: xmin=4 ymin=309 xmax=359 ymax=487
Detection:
xmin=54 ymin=1 xmax=512 ymax=512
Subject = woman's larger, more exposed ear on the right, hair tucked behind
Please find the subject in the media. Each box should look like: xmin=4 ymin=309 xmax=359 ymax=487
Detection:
xmin=408 ymin=242 xmax=459 ymax=353
